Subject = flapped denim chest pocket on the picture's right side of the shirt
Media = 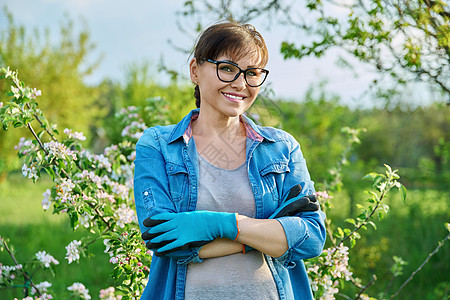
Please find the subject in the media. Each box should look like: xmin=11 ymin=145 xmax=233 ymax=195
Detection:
xmin=259 ymin=161 xmax=290 ymax=202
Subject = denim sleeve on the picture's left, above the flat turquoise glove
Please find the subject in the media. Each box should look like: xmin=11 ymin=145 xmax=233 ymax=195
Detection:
xmin=134 ymin=128 xmax=200 ymax=264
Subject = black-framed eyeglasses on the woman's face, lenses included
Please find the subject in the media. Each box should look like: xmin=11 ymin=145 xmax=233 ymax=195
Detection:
xmin=203 ymin=58 xmax=269 ymax=87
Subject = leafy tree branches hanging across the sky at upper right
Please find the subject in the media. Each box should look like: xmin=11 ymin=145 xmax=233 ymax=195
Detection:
xmin=180 ymin=0 xmax=450 ymax=101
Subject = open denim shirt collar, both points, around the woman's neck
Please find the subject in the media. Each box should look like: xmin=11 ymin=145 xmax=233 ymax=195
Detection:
xmin=168 ymin=108 xmax=275 ymax=144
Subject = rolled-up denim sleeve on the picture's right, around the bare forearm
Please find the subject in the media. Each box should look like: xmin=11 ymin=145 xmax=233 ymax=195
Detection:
xmin=276 ymin=135 xmax=326 ymax=267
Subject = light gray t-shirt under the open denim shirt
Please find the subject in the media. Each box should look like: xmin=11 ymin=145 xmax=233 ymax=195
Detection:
xmin=185 ymin=154 xmax=279 ymax=300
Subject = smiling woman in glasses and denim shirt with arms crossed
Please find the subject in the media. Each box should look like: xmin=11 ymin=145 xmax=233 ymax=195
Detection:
xmin=134 ymin=22 xmax=325 ymax=299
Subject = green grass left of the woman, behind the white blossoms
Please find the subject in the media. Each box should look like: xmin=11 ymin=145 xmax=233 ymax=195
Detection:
xmin=0 ymin=174 xmax=113 ymax=299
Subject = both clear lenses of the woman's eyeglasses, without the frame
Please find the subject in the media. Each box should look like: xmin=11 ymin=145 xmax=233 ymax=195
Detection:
xmin=217 ymin=62 xmax=267 ymax=87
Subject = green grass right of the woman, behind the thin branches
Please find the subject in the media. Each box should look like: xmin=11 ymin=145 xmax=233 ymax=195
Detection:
xmin=328 ymin=189 xmax=450 ymax=300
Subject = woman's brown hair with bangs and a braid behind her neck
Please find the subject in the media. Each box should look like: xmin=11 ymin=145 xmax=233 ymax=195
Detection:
xmin=193 ymin=22 xmax=269 ymax=107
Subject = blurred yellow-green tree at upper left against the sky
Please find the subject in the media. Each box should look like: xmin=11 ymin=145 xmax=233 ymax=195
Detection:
xmin=0 ymin=9 xmax=102 ymax=176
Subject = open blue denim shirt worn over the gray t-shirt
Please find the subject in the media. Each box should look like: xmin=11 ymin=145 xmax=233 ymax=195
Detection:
xmin=134 ymin=109 xmax=325 ymax=300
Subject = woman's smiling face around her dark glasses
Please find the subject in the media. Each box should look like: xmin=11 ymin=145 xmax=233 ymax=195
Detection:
xmin=190 ymin=54 xmax=260 ymax=117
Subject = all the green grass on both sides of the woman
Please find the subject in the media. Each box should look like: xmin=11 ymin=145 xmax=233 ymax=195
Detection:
xmin=0 ymin=173 xmax=450 ymax=300
